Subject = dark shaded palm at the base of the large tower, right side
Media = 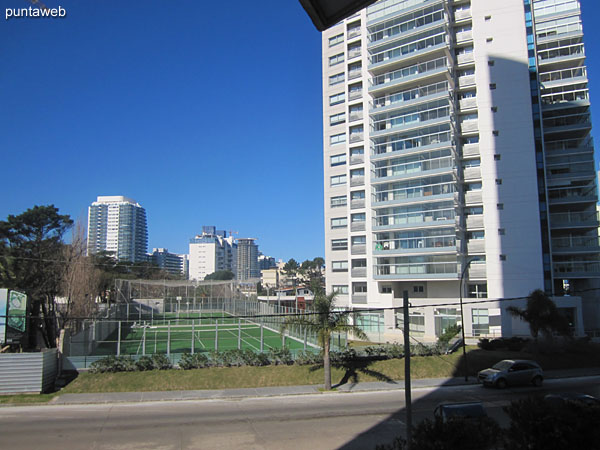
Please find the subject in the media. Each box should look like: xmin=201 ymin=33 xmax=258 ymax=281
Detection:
xmin=506 ymin=289 xmax=571 ymax=341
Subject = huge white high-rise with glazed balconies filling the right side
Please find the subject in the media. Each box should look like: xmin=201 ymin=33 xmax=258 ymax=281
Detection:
xmin=322 ymin=0 xmax=600 ymax=339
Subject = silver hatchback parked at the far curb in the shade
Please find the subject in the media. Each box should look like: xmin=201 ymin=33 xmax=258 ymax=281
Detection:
xmin=477 ymin=359 xmax=544 ymax=389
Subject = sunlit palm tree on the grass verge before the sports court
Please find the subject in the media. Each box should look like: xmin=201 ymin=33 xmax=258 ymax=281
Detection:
xmin=282 ymin=291 xmax=367 ymax=391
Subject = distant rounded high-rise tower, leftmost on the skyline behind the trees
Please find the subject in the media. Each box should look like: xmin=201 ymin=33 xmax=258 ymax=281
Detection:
xmin=87 ymin=195 xmax=148 ymax=262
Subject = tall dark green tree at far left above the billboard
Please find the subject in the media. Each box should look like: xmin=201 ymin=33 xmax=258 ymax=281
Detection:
xmin=0 ymin=205 xmax=73 ymax=347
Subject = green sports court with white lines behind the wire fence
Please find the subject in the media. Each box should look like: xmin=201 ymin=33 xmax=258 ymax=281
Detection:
xmin=94 ymin=312 xmax=311 ymax=355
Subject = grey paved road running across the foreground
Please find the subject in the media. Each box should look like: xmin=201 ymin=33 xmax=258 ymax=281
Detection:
xmin=0 ymin=376 xmax=600 ymax=450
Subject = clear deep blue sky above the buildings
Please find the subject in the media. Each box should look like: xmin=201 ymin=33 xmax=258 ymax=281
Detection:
xmin=0 ymin=0 xmax=600 ymax=261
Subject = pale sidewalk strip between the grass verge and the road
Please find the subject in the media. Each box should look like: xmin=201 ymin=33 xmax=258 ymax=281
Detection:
xmin=49 ymin=367 xmax=600 ymax=405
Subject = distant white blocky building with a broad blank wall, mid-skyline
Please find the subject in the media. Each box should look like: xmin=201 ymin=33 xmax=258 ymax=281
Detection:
xmin=188 ymin=226 xmax=237 ymax=280
